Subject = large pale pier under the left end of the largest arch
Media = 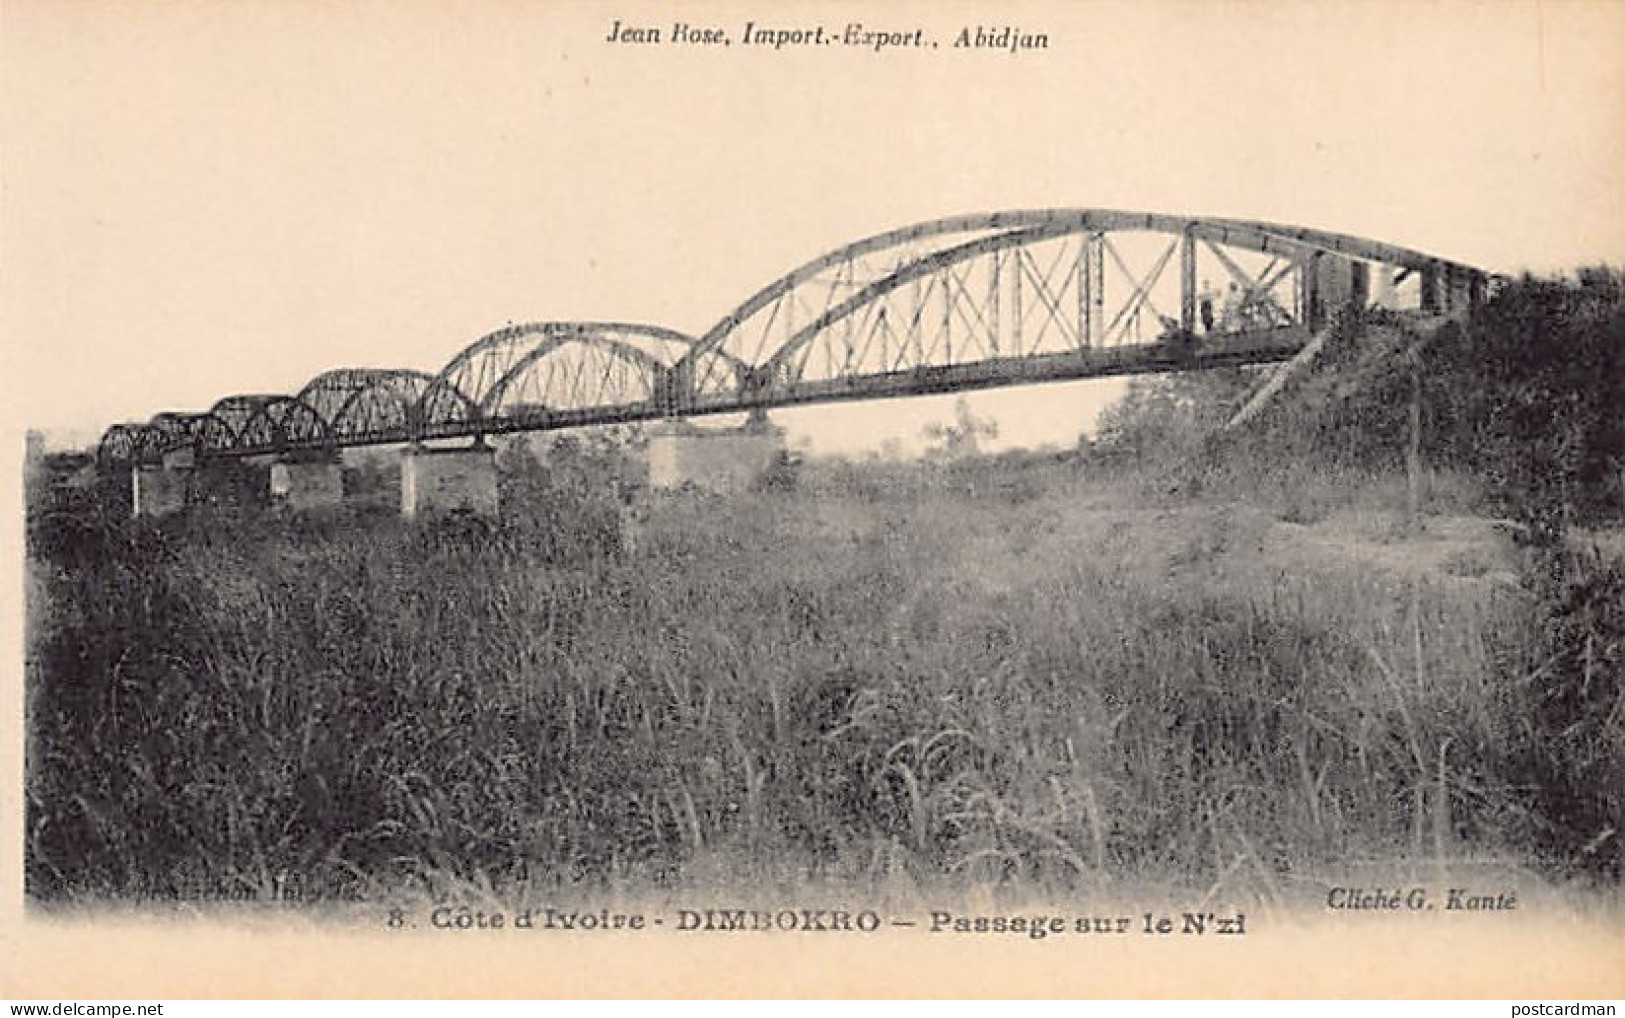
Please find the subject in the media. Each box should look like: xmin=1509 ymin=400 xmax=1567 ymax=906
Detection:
xmin=648 ymin=410 xmax=785 ymax=494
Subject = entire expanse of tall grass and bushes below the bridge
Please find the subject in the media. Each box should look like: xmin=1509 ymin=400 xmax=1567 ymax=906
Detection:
xmin=26 ymin=275 xmax=1625 ymax=903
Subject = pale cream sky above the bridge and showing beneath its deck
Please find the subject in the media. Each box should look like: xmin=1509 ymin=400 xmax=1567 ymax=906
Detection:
xmin=0 ymin=0 xmax=1625 ymax=454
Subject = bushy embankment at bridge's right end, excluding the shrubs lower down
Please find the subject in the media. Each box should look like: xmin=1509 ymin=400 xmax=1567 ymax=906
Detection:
xmin=1094 ymin=270 xmax=1625 ymax=543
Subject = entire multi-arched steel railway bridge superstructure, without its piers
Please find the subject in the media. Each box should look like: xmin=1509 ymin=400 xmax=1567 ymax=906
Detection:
xmin=98 ymin=210 xmax=1489 ymax=467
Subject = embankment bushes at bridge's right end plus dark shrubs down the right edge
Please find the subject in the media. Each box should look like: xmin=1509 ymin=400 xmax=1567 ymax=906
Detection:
xmin=1090 ymin=270 xmax=1625 ymax=878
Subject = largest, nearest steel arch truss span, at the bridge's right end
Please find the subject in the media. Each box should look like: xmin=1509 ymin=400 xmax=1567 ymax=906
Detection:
xmin=674 ymin=210 xmax=1484 ymax=413
